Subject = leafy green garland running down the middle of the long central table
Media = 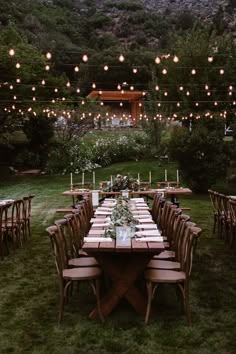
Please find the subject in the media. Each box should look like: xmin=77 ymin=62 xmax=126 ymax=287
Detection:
xmin=105 ymin=197 xmax=137 ymax=239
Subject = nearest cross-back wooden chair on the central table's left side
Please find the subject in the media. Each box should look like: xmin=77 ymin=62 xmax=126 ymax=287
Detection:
xmin=46 ymin=225 xmax=104 ymax=323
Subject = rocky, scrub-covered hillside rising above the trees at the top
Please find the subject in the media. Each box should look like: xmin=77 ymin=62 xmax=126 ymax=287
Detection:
xmin=0 ymin=0 xmax=232 ymax=56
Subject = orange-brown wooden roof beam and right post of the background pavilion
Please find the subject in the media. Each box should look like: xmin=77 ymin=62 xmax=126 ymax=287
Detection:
xmin=87 ymin=90 xmax=143 ymax=125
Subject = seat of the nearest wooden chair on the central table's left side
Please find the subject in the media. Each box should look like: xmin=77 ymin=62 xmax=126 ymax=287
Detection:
xmin=62 ymin=267 xmax=102 ymax=280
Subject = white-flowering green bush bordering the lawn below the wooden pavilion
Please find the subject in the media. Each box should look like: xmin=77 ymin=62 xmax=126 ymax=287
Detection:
xmin=47 ymin=132 xmax=149 ymax=174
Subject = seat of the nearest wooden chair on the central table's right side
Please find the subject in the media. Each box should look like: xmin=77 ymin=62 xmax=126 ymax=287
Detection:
xmin=145 ymin=269 xmax=186 ymax=283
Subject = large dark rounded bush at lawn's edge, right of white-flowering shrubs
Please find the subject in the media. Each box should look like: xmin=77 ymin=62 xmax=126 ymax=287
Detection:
xmin=169 ymin=119 xmax=230 ymax=192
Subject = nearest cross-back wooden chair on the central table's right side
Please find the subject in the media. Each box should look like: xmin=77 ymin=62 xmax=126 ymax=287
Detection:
xmin=145 ymin=227 xmax=202 ymax=324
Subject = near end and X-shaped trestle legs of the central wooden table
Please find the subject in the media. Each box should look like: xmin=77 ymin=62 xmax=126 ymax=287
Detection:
xmin=82 ymin=198 xmax=164 ymax=319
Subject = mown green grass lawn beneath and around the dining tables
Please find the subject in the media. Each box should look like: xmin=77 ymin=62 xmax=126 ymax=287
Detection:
xmin=0 ymin=161 xmax=236 ymax=354
